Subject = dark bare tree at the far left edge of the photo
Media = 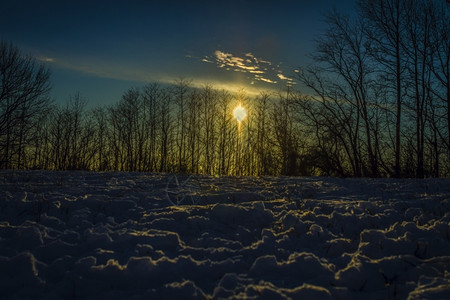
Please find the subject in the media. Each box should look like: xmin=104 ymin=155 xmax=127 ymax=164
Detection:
xmin=0 ymin=41 xmax=50 ymax=168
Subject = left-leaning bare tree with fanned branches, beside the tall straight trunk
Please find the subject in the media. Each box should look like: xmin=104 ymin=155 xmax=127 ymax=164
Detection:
xmin=297 ymin=11 xmax=379 ymax=176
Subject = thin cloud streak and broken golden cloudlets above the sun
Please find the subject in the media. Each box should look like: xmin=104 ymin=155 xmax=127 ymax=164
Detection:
xmin=38 ymin=50 xmax=291 ymax=95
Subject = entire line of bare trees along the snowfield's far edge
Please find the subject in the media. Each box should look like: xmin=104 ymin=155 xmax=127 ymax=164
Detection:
xmin=0 ymin=0 xmax=450 ymax=177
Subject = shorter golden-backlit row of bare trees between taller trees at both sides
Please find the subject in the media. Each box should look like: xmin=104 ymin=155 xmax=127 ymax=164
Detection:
xmin=1 ymin=79 xmax=300 ymax=175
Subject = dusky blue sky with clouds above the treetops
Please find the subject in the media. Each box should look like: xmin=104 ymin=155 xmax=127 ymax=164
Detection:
xmin=0 ymin=0 xmax=354 ymax=105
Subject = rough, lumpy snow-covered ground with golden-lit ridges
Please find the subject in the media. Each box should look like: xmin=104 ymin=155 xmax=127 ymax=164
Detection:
xmin=0 ymin=171 xmax=450 ymax=299
